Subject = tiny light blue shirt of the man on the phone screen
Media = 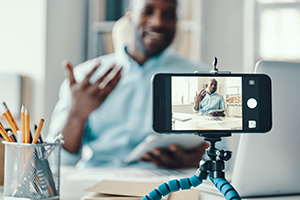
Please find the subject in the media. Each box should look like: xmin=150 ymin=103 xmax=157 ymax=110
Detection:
xmin=193 ymin=93 xmax=226 ymax=115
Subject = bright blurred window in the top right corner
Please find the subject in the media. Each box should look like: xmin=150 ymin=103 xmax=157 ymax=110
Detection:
xmin=258 ymin=0 xmax=300 ymax=60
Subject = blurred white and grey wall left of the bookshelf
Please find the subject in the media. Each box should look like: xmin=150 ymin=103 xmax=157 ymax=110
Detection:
xmin=0 ymin=0 xmax=87 ymax=134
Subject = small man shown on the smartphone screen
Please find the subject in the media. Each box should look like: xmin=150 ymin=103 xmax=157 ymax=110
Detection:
xmin=193 ymin=79 xmax=226 ymax=117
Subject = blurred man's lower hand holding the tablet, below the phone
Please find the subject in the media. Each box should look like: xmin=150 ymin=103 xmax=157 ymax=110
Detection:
xmin=140 ymin=142 xmax=209 ymax=169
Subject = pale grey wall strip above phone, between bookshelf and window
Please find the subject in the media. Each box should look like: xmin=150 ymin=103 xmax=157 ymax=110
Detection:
xmin=200 ymin=0 xmax=244 ymax=72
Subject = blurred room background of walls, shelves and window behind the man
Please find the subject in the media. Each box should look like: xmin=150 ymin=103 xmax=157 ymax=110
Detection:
xmin=0 ymin=0 xmax=300 ymax=136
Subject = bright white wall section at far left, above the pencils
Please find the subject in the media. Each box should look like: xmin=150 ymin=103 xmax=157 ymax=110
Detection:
xmin=0 ymin=0 xmax=46 ymax=123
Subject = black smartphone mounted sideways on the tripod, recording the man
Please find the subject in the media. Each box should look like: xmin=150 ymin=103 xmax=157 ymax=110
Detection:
xmin=152 ymin=73 xmax=272 ymax=134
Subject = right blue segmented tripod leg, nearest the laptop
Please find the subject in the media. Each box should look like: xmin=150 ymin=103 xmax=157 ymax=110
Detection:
xmin=209 ymin=177 xmax=241 ymax=200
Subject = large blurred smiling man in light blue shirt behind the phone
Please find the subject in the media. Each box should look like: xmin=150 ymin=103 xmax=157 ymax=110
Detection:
xmin=49 ymin=0 xmax=207 ymax=168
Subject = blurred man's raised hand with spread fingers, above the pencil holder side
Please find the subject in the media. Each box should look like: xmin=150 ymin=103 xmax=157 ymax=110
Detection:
xmin=63 ymin=62 xmax=122 ymax=120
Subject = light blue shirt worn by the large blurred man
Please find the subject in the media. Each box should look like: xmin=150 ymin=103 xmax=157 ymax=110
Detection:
xmin=47 ymin=48 xmax=209 ymax=167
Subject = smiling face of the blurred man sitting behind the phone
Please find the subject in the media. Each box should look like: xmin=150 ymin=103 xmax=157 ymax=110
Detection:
xmin=132 ymin=0 xmax=177 ymax=56
